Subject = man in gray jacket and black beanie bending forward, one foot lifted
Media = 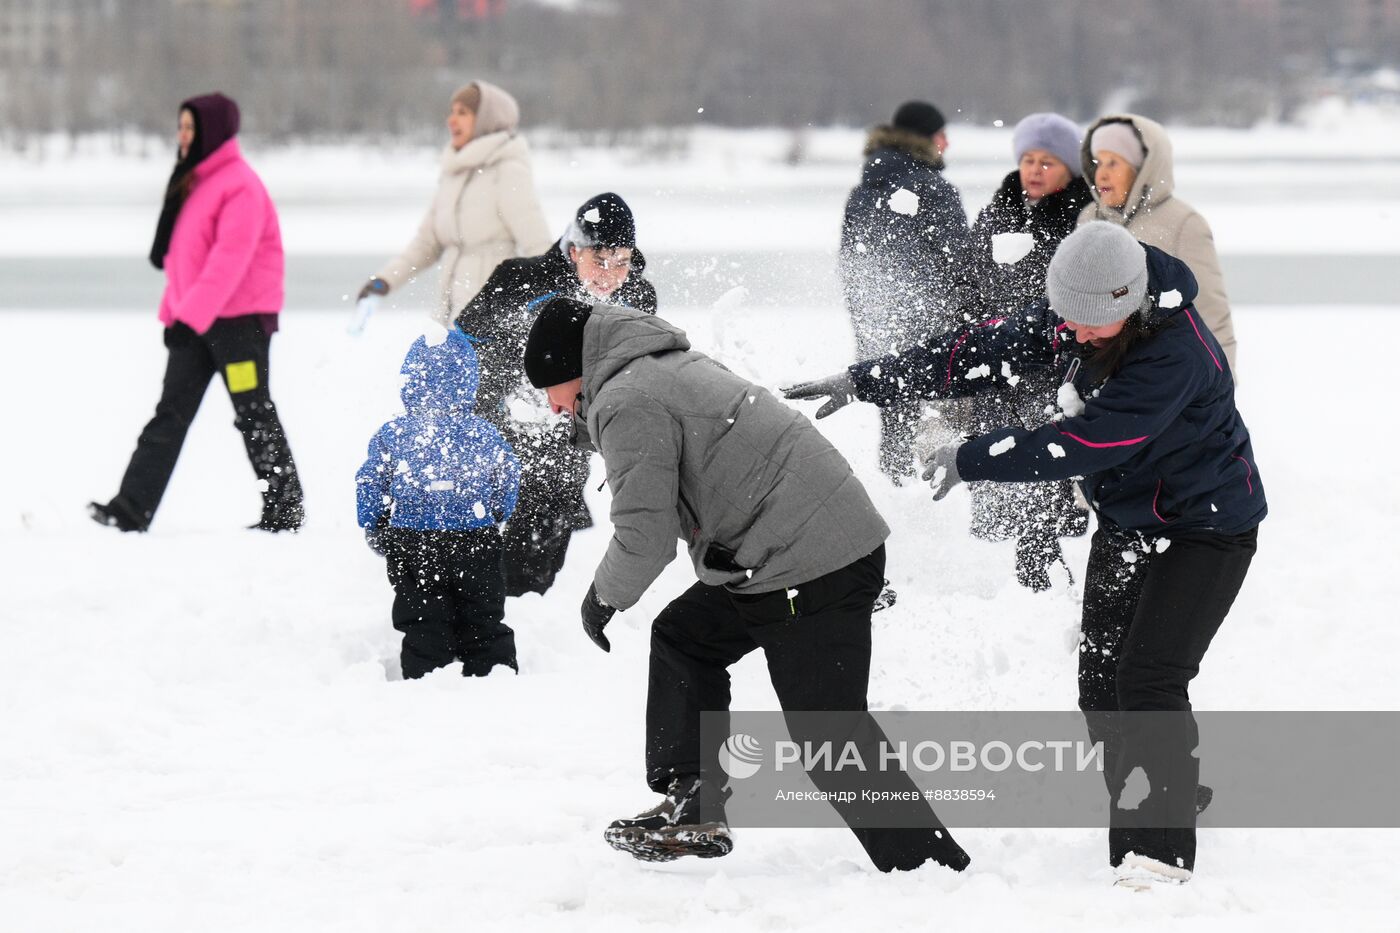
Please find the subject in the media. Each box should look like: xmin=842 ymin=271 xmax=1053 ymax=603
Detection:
xmin=525 ymin=298 xmax=970 ymax=871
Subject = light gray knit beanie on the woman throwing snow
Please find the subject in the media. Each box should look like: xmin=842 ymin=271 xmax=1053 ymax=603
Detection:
xmin=1046 ymin=220 xmax=1147 ymax=326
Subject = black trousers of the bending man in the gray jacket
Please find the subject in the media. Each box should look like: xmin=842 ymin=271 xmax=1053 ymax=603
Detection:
xmin=647 ymin=546 xmax=969 ymax=871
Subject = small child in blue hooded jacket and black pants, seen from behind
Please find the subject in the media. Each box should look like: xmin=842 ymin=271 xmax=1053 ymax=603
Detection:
xmin=356 ymin=328 xmax=519 ymax=679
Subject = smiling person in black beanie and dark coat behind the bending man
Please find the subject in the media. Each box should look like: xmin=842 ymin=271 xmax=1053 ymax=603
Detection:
xmin=456 ymin=192 xmax=657 ymax=597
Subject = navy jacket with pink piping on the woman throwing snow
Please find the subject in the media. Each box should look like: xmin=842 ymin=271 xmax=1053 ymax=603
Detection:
xmin=850 ymin=247 xmax=1268 ymax=534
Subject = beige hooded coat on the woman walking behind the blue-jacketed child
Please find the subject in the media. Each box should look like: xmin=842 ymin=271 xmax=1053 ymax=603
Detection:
xmin=377 ymin=81 xmax=554 ymax=325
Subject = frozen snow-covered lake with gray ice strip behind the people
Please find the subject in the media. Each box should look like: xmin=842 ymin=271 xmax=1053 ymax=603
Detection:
xmin=0 ymin=126 xmax=1400 ymax=311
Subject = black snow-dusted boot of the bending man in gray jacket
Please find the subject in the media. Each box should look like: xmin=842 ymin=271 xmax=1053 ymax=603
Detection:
xmin=603 ymin=776 xmax=734 ymax=862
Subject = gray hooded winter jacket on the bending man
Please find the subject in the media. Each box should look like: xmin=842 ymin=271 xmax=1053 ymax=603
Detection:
xmin=575 ymin=305 xmax=889 ymax=609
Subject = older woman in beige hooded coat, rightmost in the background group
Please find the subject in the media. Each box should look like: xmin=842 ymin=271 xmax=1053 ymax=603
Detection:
xmin=1079 ymin=113 xmax=1236 ymax=373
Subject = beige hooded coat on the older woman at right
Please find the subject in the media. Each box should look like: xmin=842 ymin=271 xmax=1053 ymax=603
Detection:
xmin=1079 ymin=113 xmax=1238 ymax=373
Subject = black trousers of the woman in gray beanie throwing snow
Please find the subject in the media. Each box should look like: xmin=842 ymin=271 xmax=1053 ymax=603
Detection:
xmin=1079 ymin=527 xmax=1257 ymax=870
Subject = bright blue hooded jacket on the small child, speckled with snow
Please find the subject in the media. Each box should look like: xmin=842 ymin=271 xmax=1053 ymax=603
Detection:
xmin=356 ymin=328 xmax=519 ymax=531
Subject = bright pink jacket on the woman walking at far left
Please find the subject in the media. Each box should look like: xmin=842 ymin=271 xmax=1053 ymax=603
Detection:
xmin=161 ymin=139 xmax=283 ymax=333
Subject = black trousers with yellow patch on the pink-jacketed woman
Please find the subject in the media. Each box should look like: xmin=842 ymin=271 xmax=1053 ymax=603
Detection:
xmin=119 ymin=315 xmax=301 ymax=523
